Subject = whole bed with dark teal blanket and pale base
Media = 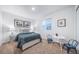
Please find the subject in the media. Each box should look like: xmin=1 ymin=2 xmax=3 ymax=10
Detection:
xmin=15 ymin=32 xmax=42 ymax=50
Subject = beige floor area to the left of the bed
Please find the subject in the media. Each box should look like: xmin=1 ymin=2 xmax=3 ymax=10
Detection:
xmin=0 ymin=41 xmax=21 ymax=54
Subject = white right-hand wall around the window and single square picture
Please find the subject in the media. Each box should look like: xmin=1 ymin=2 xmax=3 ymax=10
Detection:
xmin=38 ymin=7 xmax=75 ymax=40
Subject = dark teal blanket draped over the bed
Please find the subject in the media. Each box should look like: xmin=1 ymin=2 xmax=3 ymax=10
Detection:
xmin=15 ymin=32 xmax=42 ymax=48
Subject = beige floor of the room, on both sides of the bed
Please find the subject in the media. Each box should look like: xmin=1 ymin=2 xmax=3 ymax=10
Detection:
xmin=0 ymin=41 xmax=65 ymax=54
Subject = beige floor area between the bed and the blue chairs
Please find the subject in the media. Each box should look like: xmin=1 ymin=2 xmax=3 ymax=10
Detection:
xmin=23 ymin=41 xmax=66 ymax=54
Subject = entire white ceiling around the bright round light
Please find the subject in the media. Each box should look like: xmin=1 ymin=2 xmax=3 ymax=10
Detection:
xmin=0 ymin=5 xmax=73 ymax=19
